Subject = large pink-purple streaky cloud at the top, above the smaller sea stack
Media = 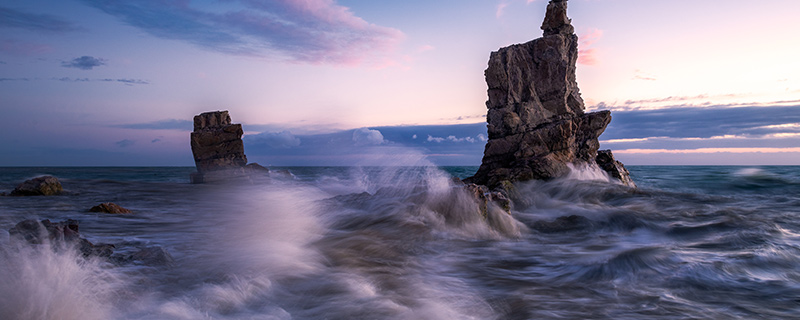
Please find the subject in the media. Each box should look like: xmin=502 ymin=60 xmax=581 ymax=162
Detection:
xmin=85 ymin=0 xmax=405 ymax=65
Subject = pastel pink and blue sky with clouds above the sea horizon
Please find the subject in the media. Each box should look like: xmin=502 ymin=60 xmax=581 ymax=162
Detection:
xmin=0 ymin=0 xmax=800 ymax=166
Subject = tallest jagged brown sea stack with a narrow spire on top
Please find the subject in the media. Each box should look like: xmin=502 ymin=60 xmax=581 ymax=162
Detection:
xmin=466 ymin=0 xmax=630 ymax=188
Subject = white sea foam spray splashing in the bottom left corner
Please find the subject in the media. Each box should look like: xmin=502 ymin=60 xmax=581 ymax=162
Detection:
xmin=0 ymin=239 xmax=125 ymax=320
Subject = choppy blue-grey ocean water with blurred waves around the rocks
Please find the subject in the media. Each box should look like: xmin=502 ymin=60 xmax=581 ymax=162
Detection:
xmin=0 ymin=166 xmax=800 ymax=319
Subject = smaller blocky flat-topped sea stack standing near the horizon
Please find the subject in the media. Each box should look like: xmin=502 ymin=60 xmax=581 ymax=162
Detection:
xmin=191 ymin=111 xmax=269 ymax=183
